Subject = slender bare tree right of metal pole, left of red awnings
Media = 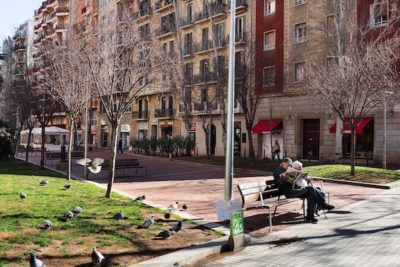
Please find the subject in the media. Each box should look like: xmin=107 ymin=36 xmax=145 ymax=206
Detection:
xmin=235 ymin=42 xmax=262 ymax=159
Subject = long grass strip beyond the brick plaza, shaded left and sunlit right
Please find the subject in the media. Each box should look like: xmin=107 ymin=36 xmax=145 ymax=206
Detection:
xmin=173 ymin=157 xmax=400 ymax=184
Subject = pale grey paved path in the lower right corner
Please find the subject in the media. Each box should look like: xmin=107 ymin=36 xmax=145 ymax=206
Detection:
xmin=209 ymin=188 xmax=400 ymax=267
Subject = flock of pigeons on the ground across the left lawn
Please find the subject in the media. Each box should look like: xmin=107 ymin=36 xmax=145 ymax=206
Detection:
xmin=19 ymin=177 xmax=188 ymax=267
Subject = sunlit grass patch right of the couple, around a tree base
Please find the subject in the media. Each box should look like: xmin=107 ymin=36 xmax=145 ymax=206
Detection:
xmin=304 ymin=164 xmax=400 ymax=184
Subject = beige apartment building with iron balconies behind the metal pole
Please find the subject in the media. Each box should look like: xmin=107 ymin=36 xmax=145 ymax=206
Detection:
xmin=173 ymin=0 xmax=255 ymax=156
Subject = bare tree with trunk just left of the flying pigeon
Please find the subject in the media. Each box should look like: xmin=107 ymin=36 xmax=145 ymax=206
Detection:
xmin=42 ymin=35 xmax=91 ymax=180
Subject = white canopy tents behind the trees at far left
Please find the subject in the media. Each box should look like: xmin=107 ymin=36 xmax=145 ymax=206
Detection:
xmin=21 ymin=126 xmax=69 ymax=151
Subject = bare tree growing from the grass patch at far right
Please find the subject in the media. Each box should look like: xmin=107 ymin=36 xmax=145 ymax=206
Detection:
xmin=306 ymin=0 xmax=400 ymax=175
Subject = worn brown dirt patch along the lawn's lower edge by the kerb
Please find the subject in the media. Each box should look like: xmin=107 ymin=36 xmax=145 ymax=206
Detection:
xmin=3 ymin=221 xmax=217 ymax=266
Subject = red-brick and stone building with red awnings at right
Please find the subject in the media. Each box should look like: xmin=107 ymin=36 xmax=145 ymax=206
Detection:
xmin=253 ymin=0 xmax=400 ymax=164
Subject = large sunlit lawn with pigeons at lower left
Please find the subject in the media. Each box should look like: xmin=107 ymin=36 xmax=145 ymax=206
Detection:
xmin=0 ymin=161 xmax=217 ymax=266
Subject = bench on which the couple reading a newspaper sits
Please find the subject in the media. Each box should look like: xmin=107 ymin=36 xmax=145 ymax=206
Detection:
xmin=238 ymin=180 xmax=306 ymax=233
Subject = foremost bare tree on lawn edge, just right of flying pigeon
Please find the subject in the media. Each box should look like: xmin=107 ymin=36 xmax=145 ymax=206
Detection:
xmin=83 ymin=7 xmax=165 ymax=198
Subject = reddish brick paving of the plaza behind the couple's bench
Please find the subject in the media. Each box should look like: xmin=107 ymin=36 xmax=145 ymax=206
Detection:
xmin=22 ymin=150 xmax=383 ymax=239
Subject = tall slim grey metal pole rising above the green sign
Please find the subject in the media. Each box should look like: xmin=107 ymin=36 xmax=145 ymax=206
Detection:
xmin=225 ymin=0 xmax=236 ymax=201
